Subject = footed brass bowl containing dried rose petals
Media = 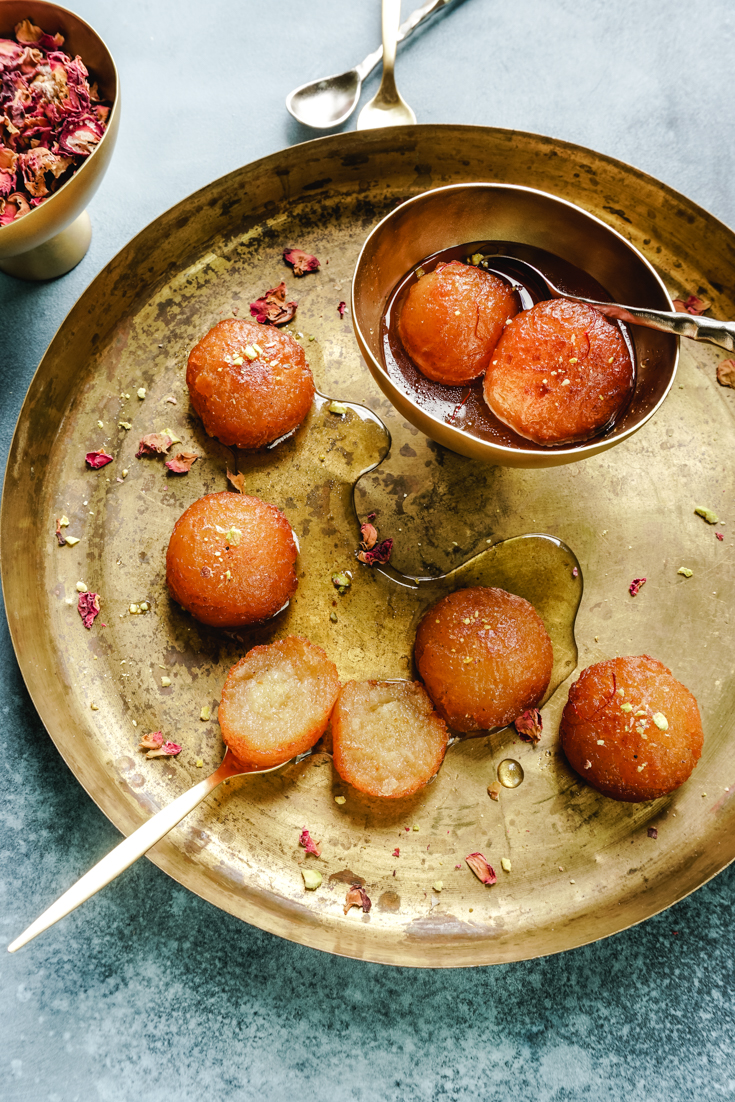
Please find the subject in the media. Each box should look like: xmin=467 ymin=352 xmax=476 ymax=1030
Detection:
xmin=0 ymin=0 xmax=120 ymax=280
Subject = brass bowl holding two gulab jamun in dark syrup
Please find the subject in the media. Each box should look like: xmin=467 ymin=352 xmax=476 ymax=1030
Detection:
xmin=352 ymin=183 xmax=679 ymax=467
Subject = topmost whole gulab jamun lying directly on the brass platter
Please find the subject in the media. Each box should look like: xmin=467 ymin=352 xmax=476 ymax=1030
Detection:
xmin=186 ymin=317 xmax=314 ymax=449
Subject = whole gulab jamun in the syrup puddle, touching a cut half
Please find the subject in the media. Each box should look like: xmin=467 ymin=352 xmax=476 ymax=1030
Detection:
xmin=414 ymin=585 xmax=553 ymax=731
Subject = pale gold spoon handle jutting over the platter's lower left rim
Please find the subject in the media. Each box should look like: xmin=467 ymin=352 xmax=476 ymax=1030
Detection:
xmin=8 ymin=754 xmax=241 ymax=953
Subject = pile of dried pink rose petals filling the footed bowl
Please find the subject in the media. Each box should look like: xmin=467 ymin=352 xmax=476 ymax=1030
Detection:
xmin=0 ymin=19 xmax=110 ymax=226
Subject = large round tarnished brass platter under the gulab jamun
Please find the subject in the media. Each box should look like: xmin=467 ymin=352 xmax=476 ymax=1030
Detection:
xmin=1 ymin=126 xmax=735 ymax=966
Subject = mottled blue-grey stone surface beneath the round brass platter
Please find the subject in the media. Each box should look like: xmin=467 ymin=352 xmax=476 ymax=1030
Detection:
xmin=0 ymin=0 xmax=735 ymax=1102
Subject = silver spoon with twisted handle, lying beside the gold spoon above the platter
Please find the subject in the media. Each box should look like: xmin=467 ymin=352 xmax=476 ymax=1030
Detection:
xmin=285 ymin=0 xmax=452 ymax=130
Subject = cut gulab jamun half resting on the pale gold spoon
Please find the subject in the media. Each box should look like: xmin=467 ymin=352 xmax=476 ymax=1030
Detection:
xmin=217 ymin=635 xmax=339 ymax=769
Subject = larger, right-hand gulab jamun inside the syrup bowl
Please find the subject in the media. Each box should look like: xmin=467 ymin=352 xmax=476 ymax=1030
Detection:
xmin=483 ymin=299 xmax=635 ymax=446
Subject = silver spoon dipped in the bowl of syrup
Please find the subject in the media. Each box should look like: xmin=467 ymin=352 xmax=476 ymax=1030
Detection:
xmin=480 ymin=257 xmax=735 ymax=352
